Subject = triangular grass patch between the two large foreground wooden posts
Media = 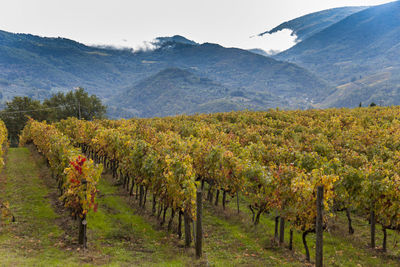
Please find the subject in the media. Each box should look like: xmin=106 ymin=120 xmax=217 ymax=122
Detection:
xmin=204 ymin=209 xmax=301 ymax=266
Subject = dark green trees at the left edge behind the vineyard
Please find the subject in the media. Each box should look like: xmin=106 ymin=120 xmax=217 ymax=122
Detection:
xmin=0 ymin=87 xmax=107 ymax=146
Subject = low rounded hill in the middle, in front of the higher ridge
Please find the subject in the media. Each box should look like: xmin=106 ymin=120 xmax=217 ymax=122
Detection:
xmin=111 ymin=68 xmax=287 ymax=117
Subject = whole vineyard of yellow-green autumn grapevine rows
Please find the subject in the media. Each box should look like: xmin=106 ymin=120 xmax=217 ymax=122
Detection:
xmin=0 ymin=107 xmax=400 ymax=266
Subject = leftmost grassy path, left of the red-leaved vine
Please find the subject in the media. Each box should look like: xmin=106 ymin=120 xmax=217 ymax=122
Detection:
xmin=0 ymin=148 xmax=78 ymax=266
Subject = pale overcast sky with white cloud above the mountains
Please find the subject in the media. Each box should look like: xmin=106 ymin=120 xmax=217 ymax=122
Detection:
xmin=0 ymin=0 xmax=391 ymax=50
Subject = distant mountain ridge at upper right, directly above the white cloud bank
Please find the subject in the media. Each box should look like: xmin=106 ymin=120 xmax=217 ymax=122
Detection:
xmin=259 ymin=7 xmax=367 ymax=42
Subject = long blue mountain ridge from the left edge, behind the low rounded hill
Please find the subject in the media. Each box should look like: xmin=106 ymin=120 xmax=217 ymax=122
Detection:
xmin=0 ymin=31 xmax=331 ymax=116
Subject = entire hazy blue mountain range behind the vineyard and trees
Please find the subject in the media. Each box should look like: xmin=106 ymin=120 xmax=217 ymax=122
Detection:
xmin=0 ymin=1 xmax=400 ymax=117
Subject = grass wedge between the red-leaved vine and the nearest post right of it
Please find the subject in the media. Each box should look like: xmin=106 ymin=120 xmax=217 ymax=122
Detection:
xmin=88 ymin=174 xmax=191 ymax=265
